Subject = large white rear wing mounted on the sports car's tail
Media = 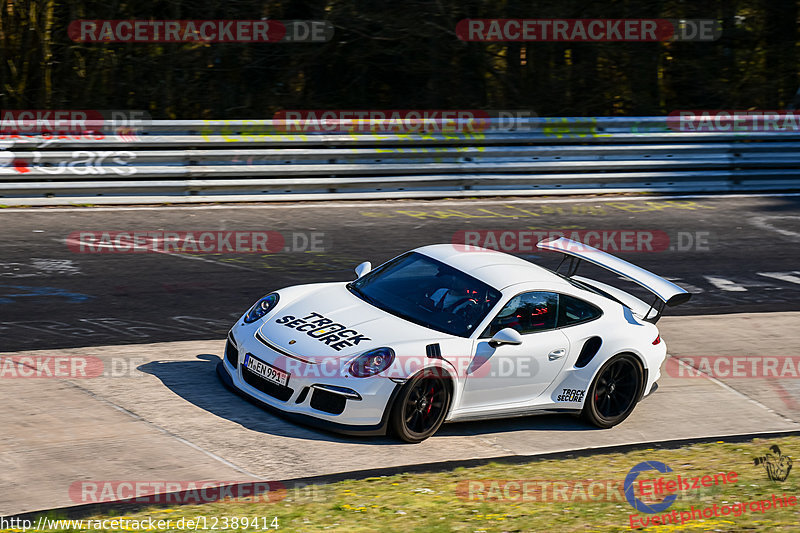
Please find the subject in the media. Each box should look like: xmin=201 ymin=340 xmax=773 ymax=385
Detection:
xmin=536 ymin=237 xmax=692 ymax=315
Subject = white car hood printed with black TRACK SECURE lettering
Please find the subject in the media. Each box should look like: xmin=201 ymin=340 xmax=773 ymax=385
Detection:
xmin=259 ymin=283 xmax=444 ymax=362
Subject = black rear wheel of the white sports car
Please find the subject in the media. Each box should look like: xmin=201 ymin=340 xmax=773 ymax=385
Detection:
xmin=581 ymin=354 xmax=644 ymax=429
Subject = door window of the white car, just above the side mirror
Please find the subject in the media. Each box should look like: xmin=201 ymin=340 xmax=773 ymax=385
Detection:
xmin=483 ymin=292 xmax=558 ymax=337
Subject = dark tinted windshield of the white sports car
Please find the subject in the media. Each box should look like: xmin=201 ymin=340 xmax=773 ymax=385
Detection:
xmin=347 ymin=252 xmax=500 ymax=337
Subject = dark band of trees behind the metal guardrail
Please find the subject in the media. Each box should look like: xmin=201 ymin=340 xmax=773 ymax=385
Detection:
xmin=0 ymin=0 xmax=800 ymax=118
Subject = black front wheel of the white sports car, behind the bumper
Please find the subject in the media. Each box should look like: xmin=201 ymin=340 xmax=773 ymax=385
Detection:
xmin=389 ymin=369 xmax=452 ymax=443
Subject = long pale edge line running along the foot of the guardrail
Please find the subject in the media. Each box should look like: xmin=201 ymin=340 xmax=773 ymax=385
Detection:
xmin=0 ymin=193 xmax=800 ymax=214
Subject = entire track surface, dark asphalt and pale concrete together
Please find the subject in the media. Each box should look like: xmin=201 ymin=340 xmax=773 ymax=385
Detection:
xmin=0 ymin=196 xmax=800 ymax=515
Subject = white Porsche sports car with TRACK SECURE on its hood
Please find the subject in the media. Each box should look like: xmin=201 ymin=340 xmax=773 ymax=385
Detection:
xmin=217 ymin=237 xmax=691 ymax=442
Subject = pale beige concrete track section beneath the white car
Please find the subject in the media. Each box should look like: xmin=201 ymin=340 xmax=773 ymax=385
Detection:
xmin=0 ymin=313 xmax=800 ymax=515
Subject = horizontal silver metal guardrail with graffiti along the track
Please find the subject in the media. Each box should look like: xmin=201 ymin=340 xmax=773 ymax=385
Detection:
xmin=0 ymin=117 xmax=800 ymax=205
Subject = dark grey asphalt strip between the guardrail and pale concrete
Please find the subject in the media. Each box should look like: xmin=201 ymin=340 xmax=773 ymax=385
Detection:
xmin=0 ymin=195 xmax=800 ymax=352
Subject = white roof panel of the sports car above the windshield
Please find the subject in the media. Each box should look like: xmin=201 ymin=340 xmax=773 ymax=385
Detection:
xmin=413 ymin=244 xmax=566 ymax=290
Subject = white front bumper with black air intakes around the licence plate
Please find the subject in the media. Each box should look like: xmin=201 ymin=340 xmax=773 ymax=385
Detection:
xmin=217 ymin=327 xmax=401 ymax=435
